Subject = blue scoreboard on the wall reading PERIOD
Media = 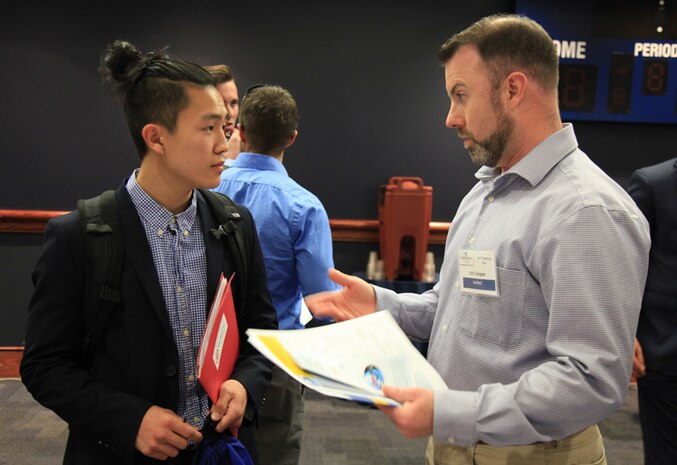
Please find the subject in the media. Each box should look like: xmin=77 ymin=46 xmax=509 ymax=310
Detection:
xmin=517 ymin=0 xmax=677 ymax=124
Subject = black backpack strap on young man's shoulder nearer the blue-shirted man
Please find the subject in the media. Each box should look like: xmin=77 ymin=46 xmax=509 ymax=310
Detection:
xmin=199 ymin=189 xmax=249 ymax=304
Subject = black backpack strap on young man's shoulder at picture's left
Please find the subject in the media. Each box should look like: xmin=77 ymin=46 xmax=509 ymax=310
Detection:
xmin=77 ymin=190 xmax=124 ymax=361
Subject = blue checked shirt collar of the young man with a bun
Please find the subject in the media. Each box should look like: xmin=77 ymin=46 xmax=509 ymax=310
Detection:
xmin=126 ymin=169 xmax=197 ymax=231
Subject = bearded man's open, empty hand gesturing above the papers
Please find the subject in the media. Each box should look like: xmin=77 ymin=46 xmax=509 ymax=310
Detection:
xmin=304 ymin=268 xmax=376 ymax=321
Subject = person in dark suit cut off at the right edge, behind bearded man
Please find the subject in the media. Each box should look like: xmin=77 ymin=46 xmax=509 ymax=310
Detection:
xmin=628 ymin=158 xmax=677 ymax=465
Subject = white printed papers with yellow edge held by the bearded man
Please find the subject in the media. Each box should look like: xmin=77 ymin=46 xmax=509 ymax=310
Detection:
xmin=247 ymin=311 xmax=447 ymax=406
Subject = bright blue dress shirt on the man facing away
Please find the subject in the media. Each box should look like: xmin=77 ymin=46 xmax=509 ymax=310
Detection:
xmin=214 ymin=152 xmax=339 ymax=329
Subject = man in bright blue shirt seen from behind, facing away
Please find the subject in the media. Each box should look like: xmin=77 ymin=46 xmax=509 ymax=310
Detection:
xmin=216 ymin=85 xmax=338 ymax=465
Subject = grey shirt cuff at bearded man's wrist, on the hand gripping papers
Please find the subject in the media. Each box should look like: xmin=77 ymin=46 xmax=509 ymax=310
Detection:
xmin=433 ymin=390 xmax=478 ymax=446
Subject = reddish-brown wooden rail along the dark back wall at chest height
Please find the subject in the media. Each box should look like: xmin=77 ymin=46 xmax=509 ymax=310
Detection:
xmin=0 ymin=210 xmax=450 ymax=244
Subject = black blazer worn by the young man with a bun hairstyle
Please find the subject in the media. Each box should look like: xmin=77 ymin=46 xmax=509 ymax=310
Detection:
xmin=20 ymin=184 xmax=277 ymax=464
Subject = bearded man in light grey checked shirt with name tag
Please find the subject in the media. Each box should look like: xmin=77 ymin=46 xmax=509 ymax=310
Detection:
xmin=307 ymin=15 xmax=650 ymax=465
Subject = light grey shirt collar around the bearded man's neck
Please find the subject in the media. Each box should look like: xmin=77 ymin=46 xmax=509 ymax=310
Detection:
xmin=475 ymin=123 xmax=578 ymax=187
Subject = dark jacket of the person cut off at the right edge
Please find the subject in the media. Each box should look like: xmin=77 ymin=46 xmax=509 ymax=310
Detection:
xmin=628 ymin=158 xmax=677 ymax=376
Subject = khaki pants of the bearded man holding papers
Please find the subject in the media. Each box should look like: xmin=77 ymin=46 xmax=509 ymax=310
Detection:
xmin=425 ymin=425 xmax=606 ymax=465
